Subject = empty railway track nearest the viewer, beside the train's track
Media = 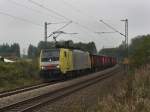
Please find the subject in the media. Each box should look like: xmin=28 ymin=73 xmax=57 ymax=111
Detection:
xmin=0 ymin=67 xmax=120 ymax=112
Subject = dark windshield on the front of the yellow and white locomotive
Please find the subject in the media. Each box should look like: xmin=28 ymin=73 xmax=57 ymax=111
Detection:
xmin=41 ymin=49 xmax=60 ymax=62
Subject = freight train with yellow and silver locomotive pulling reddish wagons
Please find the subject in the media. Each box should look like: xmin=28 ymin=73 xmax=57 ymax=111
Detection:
xmin=40 ymin=48 xmax=117 ymax=80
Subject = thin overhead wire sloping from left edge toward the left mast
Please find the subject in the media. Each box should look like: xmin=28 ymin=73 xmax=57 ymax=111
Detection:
xmin=0 ymin=11 xmax=43 ymax=27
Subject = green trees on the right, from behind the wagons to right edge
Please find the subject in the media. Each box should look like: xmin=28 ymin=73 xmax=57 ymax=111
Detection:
xmin=99 ymin=35 xmax=150 ymax=67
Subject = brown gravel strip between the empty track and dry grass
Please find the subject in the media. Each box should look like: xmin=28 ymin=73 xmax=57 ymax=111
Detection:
xmin=31 ymin=67 xmax=124 ymax=112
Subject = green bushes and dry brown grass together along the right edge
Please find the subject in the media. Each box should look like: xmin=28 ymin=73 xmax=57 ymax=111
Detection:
xmin=96 ymin=35 xmax=150 ymax=112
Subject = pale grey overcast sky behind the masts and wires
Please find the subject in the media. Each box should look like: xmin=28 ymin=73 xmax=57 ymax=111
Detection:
xmin=0 ymin=0 xmax=150 ymax=53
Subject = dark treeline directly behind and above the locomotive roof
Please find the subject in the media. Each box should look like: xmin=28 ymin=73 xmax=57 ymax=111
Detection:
xmin=28 ymin=40 xmax=97 ymax=58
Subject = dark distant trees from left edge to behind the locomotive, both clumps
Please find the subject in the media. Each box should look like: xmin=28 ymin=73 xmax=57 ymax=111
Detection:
xmin=0 ymin=40 xmax=97 ymax=58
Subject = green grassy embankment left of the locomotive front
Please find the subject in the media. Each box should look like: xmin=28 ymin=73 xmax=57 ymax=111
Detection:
xmin=0 ymin=61 xmax=40 ymax=91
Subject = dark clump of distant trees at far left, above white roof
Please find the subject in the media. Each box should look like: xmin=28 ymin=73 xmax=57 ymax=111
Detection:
xmin=0 ymin=43 xmax=20 ymax=58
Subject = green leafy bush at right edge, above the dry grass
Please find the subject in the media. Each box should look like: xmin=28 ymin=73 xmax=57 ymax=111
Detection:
xmin=130 ymin=35 xmax=150 ymax=67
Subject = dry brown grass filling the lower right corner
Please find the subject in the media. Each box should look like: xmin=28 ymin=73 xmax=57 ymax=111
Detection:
xmin=96 ymin=67 xmax=150 ymax=112
